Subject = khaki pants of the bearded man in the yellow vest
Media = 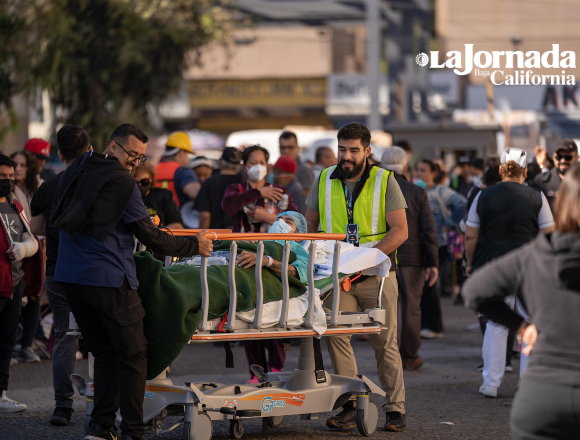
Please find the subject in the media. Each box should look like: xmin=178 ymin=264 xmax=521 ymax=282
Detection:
xmin=324 ymin=272 xmax=405 ymax=414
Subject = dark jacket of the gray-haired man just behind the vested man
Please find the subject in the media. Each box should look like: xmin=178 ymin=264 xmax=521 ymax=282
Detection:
xmin=395 ymin=174 xmax=439 ymax=267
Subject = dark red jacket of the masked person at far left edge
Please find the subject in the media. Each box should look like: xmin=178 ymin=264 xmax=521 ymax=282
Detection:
xmin=0 ymin=195 xmax=44 ymax=298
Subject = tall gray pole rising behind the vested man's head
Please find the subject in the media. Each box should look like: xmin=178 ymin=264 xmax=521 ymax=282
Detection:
xmin=366 ymin=0 xmax=383 ymax=130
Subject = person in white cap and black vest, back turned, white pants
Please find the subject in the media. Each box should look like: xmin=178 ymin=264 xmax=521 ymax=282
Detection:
xmin=465 ymin=148 xmax=554 ymax=397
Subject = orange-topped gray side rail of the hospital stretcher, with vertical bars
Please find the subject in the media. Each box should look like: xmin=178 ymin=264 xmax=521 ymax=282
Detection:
xmin=162 ymin=230 xmax=386 ymax=341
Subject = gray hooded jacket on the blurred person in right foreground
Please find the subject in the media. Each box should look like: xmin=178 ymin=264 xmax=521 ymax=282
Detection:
xmin=462 ymin=232 xmax=580 ymax=385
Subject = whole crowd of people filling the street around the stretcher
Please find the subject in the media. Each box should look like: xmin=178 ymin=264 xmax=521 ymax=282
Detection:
xmin=0 ymin=123 xmax=580 ymax=440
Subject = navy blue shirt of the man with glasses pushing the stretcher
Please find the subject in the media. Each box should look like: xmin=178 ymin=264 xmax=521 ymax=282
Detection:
xmin=54 ymin=183 xmax=149 ymax=290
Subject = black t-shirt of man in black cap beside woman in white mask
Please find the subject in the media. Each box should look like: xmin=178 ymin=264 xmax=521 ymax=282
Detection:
xmin=195 ymin=173 xmax=242 ymax=229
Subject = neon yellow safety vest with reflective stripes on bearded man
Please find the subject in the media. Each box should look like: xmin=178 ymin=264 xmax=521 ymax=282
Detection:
xmin=318 ymin=165 xmax=391 ymax=247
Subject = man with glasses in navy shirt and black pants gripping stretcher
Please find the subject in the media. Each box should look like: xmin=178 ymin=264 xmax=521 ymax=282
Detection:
xmin=50 ymin=124 xmax=213 ymax=440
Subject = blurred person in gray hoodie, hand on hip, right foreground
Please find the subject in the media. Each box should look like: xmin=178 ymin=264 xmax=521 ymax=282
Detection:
xmin=463 ymin=165 xmax=580 ymax=440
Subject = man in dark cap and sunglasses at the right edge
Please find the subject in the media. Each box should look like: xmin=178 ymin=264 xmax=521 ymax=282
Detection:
xmin=532 ymin=139 xmax=578 ymax=212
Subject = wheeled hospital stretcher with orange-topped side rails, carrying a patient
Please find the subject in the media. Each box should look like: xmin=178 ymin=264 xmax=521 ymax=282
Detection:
xmin=69 ymin=230 xmax=389 ymax=440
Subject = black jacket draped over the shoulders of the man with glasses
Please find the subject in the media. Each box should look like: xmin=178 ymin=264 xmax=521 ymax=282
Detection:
xmin=50 ymin=151 xmax=135 ymax=240
